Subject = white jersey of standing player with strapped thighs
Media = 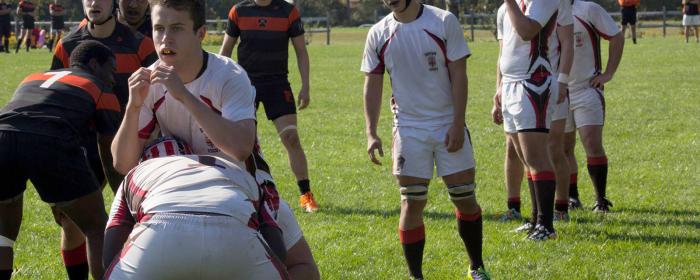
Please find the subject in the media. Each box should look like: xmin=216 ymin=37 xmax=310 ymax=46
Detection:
xmin=360 ymin=5 xmax=471 ymax=127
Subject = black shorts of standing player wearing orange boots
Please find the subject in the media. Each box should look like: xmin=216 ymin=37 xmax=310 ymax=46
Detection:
xmin=255 ymin=82 xmax=297 ymax=121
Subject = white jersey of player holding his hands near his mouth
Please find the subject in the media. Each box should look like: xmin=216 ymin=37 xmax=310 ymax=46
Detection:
xmin=139 ymin=53 xmax=255 ymax=160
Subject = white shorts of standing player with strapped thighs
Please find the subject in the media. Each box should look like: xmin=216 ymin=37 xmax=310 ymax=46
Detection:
xmin=392 ymin=125 xmax=474 ymax=179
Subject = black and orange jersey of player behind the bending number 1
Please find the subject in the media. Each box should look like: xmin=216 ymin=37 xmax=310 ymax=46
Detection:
xmin=51 ymin=22 xmax=158 ymax=108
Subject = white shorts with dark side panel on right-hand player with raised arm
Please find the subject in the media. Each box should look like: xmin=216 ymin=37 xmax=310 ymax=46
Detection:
xmin=501 ymin=76 xmax=559 ymax=133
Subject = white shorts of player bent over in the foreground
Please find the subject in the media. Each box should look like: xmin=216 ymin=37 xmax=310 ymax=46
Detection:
xmin=104 ymin=213 xmax=287 ymax=279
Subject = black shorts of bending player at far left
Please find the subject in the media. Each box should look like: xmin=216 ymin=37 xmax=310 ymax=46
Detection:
xmin=0 ymin=131 xmax=99 ymax=203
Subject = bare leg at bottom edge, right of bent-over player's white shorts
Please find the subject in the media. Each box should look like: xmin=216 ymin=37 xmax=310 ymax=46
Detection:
xmin=284 ymin=237 xmax=321 ymax=280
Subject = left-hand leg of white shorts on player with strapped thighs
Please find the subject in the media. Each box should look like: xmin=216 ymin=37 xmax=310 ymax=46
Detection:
xmin=392 ymin=127 xmax=434 ymax=179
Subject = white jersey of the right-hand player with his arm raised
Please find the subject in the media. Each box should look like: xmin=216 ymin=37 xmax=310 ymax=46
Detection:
xmin=497 ymin=0 xmax=560 ymax=83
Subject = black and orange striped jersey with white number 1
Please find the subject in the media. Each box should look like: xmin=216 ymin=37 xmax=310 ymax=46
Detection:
xmin=0 ymin=68 xmax=121 ymax=141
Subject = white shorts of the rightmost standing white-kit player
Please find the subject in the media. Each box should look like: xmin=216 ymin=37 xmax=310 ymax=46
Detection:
xmin=566 ymin=87 xmax=605 ymax=132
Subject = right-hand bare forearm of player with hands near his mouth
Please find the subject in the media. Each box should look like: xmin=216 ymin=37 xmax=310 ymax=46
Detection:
xmin=182 ymin=93 xmax=255 ymax=161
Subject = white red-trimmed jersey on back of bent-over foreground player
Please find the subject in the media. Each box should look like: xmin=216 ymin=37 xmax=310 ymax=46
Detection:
xmin=107 ymin=155 xmax=259 ymax=229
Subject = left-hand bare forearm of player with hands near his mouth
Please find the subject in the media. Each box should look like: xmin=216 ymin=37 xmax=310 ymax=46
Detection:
xmin=111 ymin=105 xmax=143 ymax=174
